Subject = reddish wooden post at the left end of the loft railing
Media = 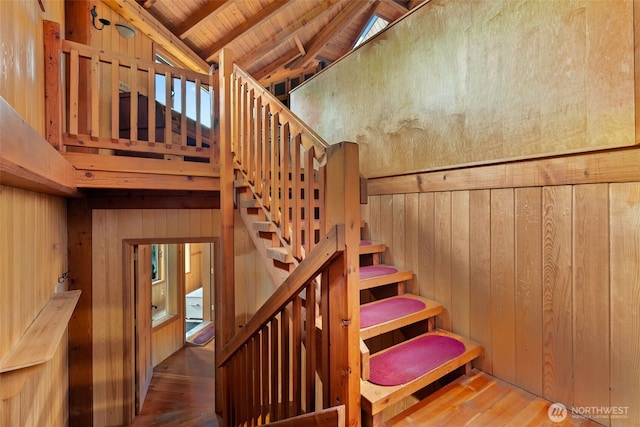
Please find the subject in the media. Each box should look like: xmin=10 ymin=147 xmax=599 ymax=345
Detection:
xmin=44 ymin=21 xmax=62 ymax=151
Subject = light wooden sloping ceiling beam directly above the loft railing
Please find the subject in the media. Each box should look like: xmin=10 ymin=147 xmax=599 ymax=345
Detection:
xmin=103 ymin=0 xmax=209 ymax=74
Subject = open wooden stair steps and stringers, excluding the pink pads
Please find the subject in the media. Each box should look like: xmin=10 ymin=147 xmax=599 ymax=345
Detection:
xmin=236 ymin=179 xmax=482 ymax=427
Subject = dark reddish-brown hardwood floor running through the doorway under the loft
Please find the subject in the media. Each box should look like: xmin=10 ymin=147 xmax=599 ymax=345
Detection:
xmin=133 ymin=341 xmax=221 ymax=427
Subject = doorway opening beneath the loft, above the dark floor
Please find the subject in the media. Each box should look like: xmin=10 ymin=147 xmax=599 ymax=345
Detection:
xmin=125 ymin=239 xmax=215 ymax=416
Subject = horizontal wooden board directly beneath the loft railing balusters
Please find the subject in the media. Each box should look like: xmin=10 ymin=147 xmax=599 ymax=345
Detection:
xmin=77 ymin=169 xmax=220 ymax=191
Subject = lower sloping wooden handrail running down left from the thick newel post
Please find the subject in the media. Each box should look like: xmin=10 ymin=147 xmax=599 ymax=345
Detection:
xmin=216 ymin=225 xmax=344 ymax=367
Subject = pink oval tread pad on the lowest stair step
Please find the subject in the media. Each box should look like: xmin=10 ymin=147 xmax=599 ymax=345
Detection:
xmin=369 ymin=335 xmax=465 ymax=386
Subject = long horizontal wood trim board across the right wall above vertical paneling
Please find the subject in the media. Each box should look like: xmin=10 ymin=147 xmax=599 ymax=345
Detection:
xmin=367 ymin=147 xmax=640 ymax=195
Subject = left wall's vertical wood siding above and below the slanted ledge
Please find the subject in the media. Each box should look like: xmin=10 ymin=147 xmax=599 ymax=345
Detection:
xmin=0 ymin=186 xmax=69 ymax=427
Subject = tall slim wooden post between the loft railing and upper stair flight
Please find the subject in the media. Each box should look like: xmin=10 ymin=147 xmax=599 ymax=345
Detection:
xmin=215 ymin=49 xmax=237 ymax=419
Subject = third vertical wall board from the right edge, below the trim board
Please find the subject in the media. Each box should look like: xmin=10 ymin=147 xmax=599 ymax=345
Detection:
xmin=542 ymin=186 xmax=573 ymax=405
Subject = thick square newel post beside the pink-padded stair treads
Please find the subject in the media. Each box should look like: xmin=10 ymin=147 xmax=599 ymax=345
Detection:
xmin=323 ymin=142 xmax=360 ymax=426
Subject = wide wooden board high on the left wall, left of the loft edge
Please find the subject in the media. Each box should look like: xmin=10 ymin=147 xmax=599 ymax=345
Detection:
xmin=0 ymin=97 xmax=78 ymax=196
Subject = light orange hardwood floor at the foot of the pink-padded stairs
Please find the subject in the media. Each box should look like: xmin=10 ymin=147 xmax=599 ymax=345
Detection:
xmin=385 ymin=370 xmax=600 ymax=427
